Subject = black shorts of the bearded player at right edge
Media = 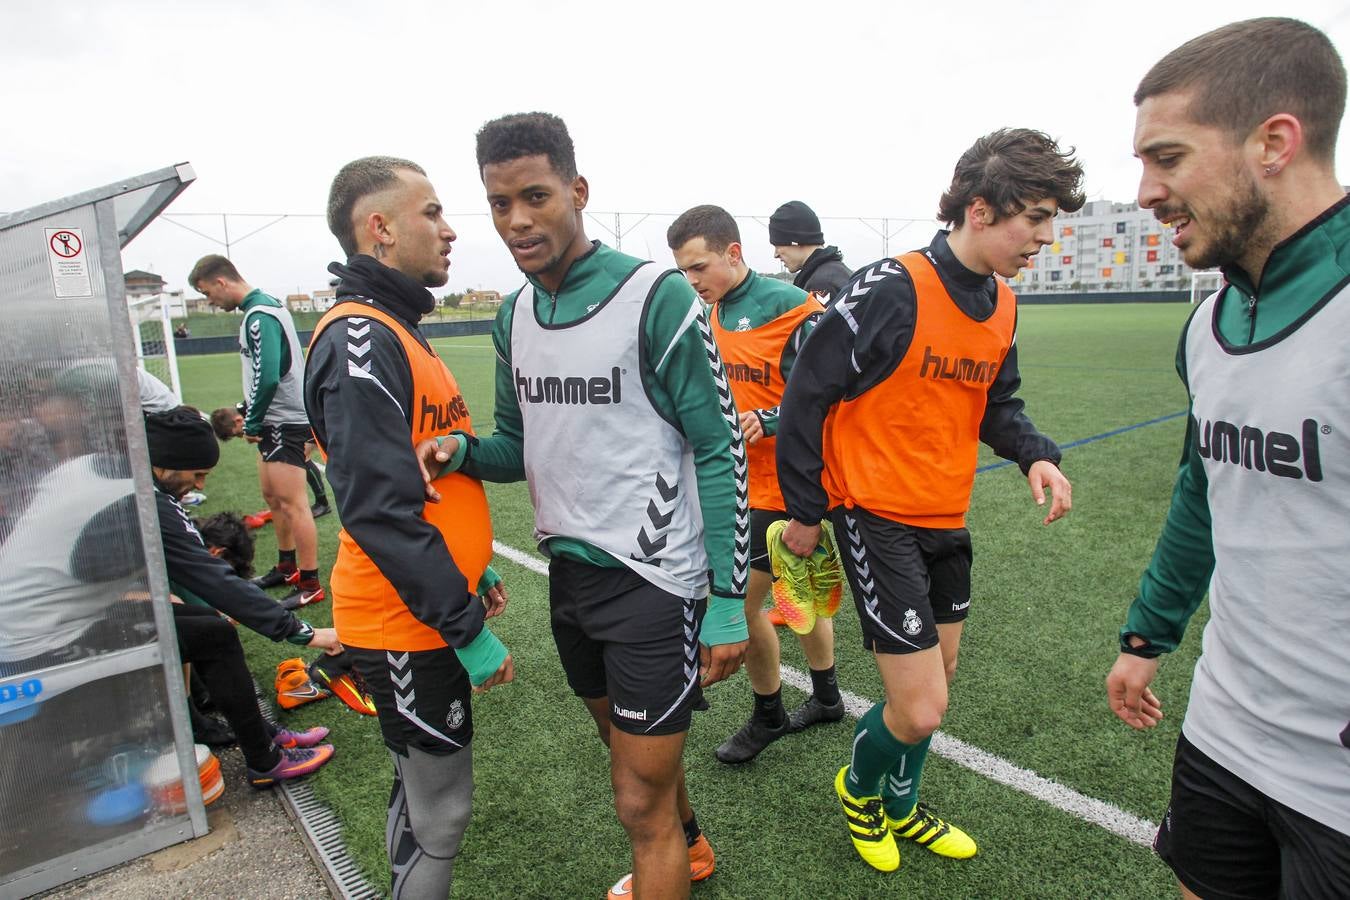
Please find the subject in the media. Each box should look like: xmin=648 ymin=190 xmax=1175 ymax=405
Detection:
xmin=1153 ymin=734 xmax=1350 ymax=900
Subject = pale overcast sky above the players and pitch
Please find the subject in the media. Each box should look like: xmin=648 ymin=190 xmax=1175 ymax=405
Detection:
xmin=0 ymin=0 xmax=1350 ymax=294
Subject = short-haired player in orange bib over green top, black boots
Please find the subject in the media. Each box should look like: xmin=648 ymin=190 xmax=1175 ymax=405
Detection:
xmin=666 ymin=206 xmax=844 ymax=762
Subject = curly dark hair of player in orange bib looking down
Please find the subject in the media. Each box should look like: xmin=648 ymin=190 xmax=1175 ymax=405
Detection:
xmin=937 ymin=128 xmax=1087 ymax=228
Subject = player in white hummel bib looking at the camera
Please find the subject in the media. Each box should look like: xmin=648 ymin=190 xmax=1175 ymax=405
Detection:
xmin=426 ymin=113 xmax=749 ymax=897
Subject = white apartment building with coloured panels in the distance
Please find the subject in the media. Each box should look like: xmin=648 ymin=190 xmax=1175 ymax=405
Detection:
xmin=1008 ymin=200 xmax=1191 ymax=294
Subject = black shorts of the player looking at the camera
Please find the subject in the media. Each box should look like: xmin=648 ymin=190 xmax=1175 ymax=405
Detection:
xmin=548 ymin=556 xmax=707 ymax=734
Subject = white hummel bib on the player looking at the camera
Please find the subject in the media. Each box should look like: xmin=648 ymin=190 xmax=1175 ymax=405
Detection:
xmin=510 ymin=263 xmax=709 ymax=598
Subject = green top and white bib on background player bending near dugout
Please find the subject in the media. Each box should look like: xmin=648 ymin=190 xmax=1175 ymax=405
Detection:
xmin=239 ymin=289 xmax=309 ymax=434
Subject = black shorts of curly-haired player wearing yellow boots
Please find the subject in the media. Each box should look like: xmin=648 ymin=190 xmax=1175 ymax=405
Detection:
xmin=833 ymin=506 xmax=972 ymax=653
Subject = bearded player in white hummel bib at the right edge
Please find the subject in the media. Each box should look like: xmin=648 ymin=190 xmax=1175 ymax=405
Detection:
xmin=1107 ymin=19 xmax=1350 ymax=897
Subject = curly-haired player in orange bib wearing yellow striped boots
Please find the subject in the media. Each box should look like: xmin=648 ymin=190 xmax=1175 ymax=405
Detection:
xmin=778 ymin=128 xmax=1084 ymax=872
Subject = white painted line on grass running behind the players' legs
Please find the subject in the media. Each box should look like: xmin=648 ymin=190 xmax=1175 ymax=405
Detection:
xmin=493 ymin=541 xmax=1158 ymax=846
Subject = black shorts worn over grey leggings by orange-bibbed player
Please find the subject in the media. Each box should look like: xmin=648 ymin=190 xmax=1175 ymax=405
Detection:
xmin=347 ymin=646 xmax=474 ymax=756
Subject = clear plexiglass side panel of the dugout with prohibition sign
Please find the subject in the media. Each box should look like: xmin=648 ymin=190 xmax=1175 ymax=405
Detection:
xmin=0 ymin=167 xmax=200 ymax=896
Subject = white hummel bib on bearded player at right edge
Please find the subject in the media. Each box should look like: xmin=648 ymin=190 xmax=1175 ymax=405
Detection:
xmin=1183 ymin=287 xmax=1350 ymax=834
